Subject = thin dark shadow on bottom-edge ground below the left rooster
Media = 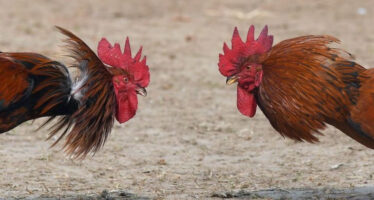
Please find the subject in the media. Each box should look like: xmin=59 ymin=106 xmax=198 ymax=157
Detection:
xmin=6 ymin=190 xmax=150 ymax=200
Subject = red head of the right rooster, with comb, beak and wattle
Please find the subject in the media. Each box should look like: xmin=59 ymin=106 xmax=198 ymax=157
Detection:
xmin=218 ymin=25 xmax=273 ymax=117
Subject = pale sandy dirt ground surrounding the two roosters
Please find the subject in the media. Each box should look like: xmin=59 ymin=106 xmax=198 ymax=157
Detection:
xmin=0 ymin=0 xmax=374 ymax=199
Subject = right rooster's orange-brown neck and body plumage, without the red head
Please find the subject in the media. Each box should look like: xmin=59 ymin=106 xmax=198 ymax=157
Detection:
xmin=256 ymin=36 xmax=374 ymax=148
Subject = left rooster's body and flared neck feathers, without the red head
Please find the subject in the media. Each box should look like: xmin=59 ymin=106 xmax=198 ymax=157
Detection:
xmin=0 ymin=28 xmax=116 ymax=158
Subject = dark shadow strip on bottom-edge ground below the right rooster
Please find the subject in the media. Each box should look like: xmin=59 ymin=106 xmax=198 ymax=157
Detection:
xmin=212 ymin=186 xmax=374 ymax=200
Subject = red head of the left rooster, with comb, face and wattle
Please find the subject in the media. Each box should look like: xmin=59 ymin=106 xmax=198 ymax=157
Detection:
xmin=98 ymin=38 xmax=150 ymax=123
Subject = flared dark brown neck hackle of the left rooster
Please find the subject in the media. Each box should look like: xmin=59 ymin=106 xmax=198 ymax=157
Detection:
xmin=49 ymin=27 xmax=116 ymax=157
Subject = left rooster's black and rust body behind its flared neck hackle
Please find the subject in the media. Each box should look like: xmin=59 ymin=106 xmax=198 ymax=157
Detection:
xmin=0 ymin=53 xmax=74 ymax=132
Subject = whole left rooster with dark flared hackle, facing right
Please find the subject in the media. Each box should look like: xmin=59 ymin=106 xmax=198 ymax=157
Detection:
xmin=0 ymin=27 xmax=150 ymax=158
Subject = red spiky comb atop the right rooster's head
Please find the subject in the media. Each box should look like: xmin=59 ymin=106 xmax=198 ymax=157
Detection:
xmin=218 ymin=25 xmax=273 ymax=76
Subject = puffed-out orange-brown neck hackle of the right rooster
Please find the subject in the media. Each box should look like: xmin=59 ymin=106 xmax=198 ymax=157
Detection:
xmin=258 ymin=36 xmax=363 ymax=142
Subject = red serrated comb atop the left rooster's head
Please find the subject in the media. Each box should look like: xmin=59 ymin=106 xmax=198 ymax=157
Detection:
xmin=97 ymin=37 xmax=150 ymax=87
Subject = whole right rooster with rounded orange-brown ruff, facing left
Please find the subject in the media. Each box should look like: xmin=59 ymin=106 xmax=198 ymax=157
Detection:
xmin=218 ymin=25 xmax=374 ymax=149
